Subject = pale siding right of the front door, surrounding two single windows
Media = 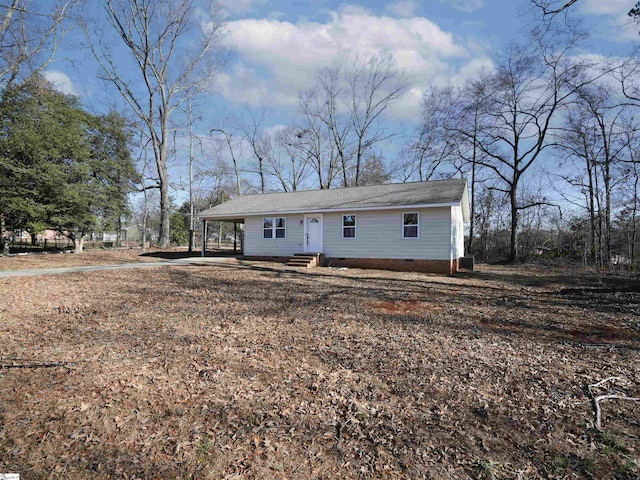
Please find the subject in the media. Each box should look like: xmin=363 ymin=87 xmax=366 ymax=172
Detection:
xmin=323 ymin=207 xmax=452 ymax=260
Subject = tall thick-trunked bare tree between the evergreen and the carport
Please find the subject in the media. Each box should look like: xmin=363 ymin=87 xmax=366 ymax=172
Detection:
xmin=84 ymin=0 xmax=223 ymax=247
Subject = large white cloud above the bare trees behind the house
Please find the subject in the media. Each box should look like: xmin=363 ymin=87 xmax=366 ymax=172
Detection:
xmin=210 ymin=6 xmax=490 ymax=118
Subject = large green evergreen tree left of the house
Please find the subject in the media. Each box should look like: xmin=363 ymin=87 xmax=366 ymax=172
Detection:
xmin=0 ymin=77 xmax=137 ymax=251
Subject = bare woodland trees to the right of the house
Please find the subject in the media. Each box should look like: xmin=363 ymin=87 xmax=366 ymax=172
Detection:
xmin=405 ymin=14 xmax=640 ymax=267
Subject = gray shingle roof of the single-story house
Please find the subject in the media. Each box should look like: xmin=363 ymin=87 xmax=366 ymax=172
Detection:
xmin=198 ymin=179 xmax=468 ymax=220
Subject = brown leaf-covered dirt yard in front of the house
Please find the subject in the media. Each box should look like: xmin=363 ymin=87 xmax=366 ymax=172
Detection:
xmin=0 ymin=252 xmax=640 ymax=479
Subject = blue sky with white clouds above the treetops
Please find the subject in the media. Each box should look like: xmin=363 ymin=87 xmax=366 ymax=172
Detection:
xmin=38 ymin=0 xmax=638 ymax=199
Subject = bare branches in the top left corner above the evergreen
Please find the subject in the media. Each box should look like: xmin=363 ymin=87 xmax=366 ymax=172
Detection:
xmin=0 ymin=0 xmax=78 ymax=86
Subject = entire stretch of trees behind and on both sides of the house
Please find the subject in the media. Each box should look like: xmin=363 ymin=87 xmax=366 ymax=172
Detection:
xmin=0 ymin=0 xmax=640 ymax=266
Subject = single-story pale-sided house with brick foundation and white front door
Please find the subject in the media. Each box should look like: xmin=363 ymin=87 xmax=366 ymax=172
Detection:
xmin=198 ymin=180 xmax=469 ymax=273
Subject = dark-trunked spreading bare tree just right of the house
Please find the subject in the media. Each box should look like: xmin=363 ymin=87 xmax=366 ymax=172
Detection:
xmin=463 ymin=26 xmax=588 ymax=262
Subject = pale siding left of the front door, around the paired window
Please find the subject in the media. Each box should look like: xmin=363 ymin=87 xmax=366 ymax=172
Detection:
xmin=244 ymin=215 xmax=304 ymax=257
